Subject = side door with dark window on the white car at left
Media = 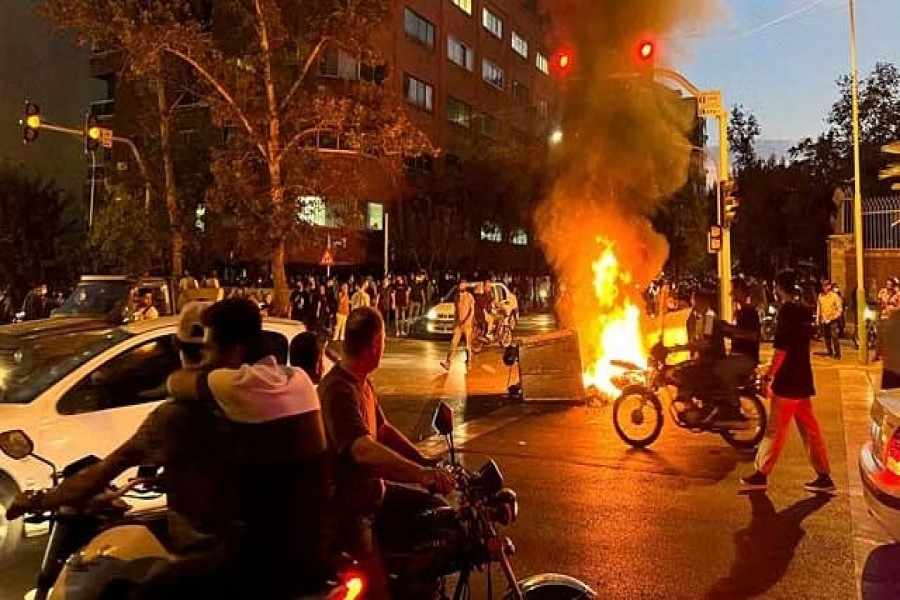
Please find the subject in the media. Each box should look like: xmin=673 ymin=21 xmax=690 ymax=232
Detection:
xmin=41 ymin=329 xmax=180 ymax=488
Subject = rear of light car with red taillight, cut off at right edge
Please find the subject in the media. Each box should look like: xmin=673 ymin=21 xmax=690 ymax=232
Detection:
xmin=859 ymin=389 xmax=900 ymax=540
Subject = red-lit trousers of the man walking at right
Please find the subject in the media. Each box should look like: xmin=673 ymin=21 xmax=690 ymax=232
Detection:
xmin=756 ymin=396 xmax=831 ymax=475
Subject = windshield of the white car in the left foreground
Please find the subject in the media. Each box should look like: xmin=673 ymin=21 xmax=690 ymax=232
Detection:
xmin=0 ymin=329 xmax=131 ymax=404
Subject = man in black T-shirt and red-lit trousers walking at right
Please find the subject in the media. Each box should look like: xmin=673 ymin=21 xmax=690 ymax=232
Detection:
xmin=741 ymin=271 xmax=835 ymax=493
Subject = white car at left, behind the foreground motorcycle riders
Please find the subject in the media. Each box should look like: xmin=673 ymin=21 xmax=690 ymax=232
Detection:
xmin=0 ymin=317 xmax=304 ymax=562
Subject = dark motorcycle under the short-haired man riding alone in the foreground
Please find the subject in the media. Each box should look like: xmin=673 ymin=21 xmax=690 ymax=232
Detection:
xmin=379 ymin=403 xmax=597 ymax=600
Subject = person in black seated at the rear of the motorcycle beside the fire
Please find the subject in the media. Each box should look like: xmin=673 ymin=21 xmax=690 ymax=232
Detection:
xmin=713 ymin=278 xmax=760 ymax=420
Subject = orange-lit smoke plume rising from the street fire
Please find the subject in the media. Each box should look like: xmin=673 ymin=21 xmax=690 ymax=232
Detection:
xmin=535 ymin=0 xmax=715 ymax=368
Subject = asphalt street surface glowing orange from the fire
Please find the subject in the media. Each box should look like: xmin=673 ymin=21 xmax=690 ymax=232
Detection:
xmin=0 ymin=316 xmax=896 ymax=599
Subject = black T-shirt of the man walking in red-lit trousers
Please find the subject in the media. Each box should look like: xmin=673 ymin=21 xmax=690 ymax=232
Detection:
xmin=772 ymin=302 xmax=816 ymax=398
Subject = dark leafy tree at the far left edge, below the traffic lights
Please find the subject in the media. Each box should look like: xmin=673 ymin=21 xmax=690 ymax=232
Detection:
xmin=0 ymin=163 xmax=85 ymax=294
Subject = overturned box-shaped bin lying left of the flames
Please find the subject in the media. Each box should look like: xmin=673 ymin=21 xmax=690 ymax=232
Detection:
xmin=519 ymin=330 xmax=586 ymax=403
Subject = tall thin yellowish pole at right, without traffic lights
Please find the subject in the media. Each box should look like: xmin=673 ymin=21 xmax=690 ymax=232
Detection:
xmin=849 ymin=0 xmax=869 ymax=365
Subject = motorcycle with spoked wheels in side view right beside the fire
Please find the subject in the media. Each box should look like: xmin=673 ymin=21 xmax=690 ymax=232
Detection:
xmin=612 ymin=345 xmax=766 ymax=449
